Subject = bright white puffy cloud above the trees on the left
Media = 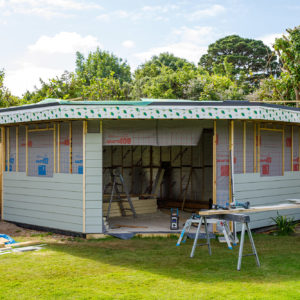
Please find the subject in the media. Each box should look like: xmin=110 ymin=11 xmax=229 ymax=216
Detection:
xmin=28 ymin=32 xmax=101 ymax=54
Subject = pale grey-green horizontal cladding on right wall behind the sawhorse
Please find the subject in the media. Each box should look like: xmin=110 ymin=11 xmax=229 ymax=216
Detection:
xmin=234 ymin=172 xmax=300 ymax=228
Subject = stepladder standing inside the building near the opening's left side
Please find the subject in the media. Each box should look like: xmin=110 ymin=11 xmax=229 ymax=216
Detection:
xmin=106 ymin=169 xmax=136 ymax=220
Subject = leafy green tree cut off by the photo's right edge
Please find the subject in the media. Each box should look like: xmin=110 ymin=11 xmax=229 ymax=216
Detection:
xmin=274 ymin=26 xmax=300 ymax=102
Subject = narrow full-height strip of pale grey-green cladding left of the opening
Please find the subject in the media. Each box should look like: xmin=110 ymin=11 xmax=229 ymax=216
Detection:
xmin=85 ymin=130 xmax=102 ymax=233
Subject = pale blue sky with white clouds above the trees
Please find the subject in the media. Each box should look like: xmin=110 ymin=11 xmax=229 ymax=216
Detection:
xmin=0 ymin=0 xmax=300 ymax=96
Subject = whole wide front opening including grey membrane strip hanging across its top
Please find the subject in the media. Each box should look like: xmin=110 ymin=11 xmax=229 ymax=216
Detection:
xmin=103 ymin=121 xmax=213 ymax=232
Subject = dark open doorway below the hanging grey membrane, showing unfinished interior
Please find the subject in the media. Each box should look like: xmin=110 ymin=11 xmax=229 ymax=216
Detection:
xmin=103 ymin=128 xmax=213 ymax=233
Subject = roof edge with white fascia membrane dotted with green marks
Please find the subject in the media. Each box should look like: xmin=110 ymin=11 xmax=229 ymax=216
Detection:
xmin=0 ymin=100 xmax=300 ymax=124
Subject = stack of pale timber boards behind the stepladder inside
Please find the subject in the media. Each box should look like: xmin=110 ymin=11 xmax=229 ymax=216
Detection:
xmin=102 ymin=195 xmax=157 ymax=217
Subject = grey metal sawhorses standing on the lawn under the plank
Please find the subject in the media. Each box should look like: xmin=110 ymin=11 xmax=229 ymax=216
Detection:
xmin=177 ymin=214 xmax=260 ymax=271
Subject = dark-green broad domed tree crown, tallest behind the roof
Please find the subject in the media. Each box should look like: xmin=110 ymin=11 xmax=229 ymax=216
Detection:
xmin=198 ymin=35 xmax=279 ymax=85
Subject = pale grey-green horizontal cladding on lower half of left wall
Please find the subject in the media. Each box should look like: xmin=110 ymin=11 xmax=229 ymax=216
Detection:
xmin=3 ymin=172 xmax=83 ymax=232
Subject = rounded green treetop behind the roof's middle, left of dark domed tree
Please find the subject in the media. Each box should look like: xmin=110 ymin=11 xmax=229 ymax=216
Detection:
xmin=134 ymin=52 xmax=196 ymax=79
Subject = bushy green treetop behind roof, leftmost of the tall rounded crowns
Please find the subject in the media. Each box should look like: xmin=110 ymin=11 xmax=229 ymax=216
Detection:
xmin=76 ymin=48 xmax=131 ymax=86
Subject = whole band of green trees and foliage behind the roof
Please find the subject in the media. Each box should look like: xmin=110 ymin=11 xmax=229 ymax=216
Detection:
xmin=0 ymin=26 xmax=300 ymax=107
